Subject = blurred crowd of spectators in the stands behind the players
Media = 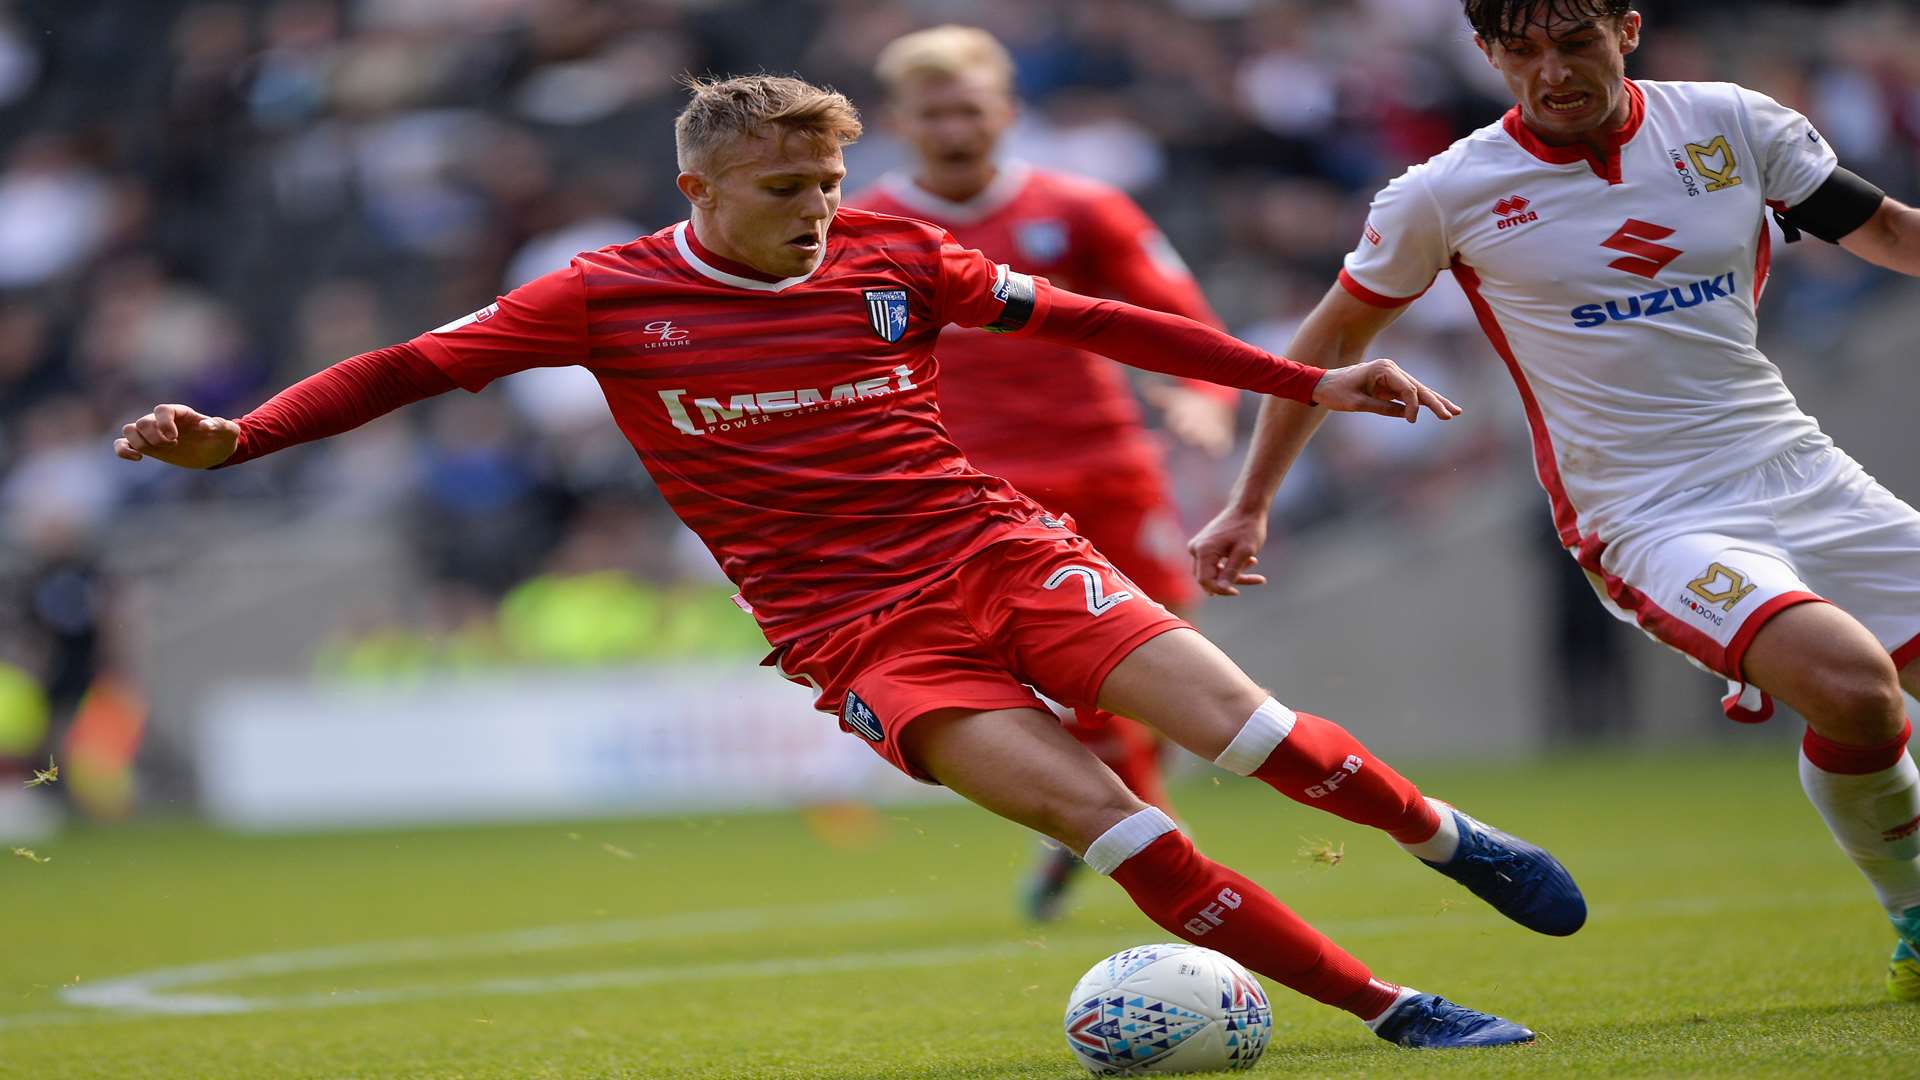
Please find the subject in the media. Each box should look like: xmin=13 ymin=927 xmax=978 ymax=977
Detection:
xmin=0 ymin=0 xmax=1920 ymax=795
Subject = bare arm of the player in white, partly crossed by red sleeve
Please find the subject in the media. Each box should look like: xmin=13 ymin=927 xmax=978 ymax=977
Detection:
xmin=1187 ymin=276 xmax=1413 ymax=596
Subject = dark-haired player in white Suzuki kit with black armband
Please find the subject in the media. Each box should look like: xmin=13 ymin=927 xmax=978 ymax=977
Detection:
xmin=1190 ymin=0 xmax=1920 ymax=1001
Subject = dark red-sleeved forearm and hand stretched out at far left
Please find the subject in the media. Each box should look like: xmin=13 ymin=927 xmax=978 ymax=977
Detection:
xmin=113 ymin=344 xmax=453 ymax=469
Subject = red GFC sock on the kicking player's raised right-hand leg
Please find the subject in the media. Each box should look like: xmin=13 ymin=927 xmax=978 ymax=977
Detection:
xmin=1254 ymin=713 xmax=1440 ymax=844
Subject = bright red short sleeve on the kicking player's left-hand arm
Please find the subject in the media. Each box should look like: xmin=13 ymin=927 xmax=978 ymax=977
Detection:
xmin=409 ymin=263 xmax=588 ymax=390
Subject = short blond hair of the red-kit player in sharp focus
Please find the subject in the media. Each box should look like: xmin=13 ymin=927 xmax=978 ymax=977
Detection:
xmin=674 ymin=75 xmax=862 ymax=173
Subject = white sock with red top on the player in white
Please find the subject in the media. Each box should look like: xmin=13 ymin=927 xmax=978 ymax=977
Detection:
xmin=1799 ymin=749 xmax=1920 ymax=915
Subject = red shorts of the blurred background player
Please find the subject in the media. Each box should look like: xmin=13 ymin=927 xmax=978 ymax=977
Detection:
xmin=1014 ymin=473 xmax=1200 ymax=607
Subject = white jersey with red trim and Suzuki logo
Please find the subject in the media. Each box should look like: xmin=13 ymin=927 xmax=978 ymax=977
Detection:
xmin=1340 ymin=81 xmax=1837 ymax=548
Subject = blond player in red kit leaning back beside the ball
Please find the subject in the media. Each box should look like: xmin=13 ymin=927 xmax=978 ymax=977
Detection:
xmin=115 ymin=75 xmax=1586 ymax=1045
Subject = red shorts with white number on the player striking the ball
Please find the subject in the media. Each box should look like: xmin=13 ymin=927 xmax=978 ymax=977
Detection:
xmin=778 ymin=532 xmax=1188 ymax=782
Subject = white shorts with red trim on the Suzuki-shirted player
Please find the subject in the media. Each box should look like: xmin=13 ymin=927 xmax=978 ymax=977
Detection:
xmin=1574 ymin=434 xmax=1920 ymax=723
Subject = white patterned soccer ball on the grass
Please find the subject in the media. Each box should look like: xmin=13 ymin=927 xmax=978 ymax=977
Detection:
xmin=1066 ymin=944 xmax=1273 ymax=1076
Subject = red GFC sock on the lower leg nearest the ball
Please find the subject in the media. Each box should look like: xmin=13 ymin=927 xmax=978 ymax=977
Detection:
xmin=1112 ymin=826 xmax=1400 ymax=1020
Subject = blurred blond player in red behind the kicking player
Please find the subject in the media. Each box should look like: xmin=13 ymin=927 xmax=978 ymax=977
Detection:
xmin=847 ymin=25 xmax=1238 ymax=920
